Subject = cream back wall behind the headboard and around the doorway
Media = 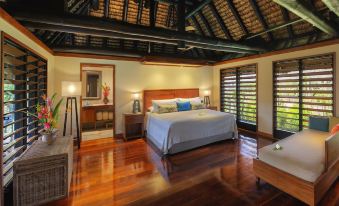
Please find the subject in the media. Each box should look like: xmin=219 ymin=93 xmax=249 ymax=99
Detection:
xmin=54 ymin=56 xmax=213 ymax=133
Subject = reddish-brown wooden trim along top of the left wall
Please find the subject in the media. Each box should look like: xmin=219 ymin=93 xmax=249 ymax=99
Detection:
xmin=0 ymin=7 xmax=54 ymax=55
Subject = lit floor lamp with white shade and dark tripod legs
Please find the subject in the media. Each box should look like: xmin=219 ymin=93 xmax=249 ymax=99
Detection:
xmin=61 ymin=81 xmax=81 ymax=148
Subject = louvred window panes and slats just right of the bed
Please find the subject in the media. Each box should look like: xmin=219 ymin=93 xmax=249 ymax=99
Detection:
xmin=220 ymin=64 xmax=257 ymax=131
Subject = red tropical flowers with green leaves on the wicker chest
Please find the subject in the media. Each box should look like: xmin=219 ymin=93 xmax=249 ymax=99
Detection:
xmin=29 ymin=93 xmax=63 ymax=134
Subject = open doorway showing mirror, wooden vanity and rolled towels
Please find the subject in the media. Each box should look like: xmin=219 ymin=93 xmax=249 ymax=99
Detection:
xmin=80 ymin=63 xmax=116 ymax=141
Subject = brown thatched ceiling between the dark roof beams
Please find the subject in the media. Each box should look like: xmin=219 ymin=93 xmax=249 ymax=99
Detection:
xmin=1 ymin=0 xmax=338 ymax=62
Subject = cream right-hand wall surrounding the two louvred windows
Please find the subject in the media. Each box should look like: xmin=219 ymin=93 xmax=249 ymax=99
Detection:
xmin=213 ymin=44 xmax=339 ymax=134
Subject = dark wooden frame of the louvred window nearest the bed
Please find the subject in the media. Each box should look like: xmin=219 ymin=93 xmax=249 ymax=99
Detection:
xmin=219 ymin=63 xmax=259 ymax=132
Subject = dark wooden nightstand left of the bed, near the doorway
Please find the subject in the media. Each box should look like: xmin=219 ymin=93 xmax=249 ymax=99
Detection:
xmin=124 ymin=113 xmax=144 ymax=140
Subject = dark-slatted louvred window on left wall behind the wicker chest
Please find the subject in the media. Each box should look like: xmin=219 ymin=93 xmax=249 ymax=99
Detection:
xmin=1 ymin=35 xmax=47 ymax=187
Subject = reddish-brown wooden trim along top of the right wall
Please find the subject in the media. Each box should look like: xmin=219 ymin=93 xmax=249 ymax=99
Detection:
xmin=213 ymin=39 xmax=339 ymax=66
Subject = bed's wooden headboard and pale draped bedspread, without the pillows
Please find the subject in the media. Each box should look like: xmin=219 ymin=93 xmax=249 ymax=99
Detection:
xmin=144 ymin=89 xmax=238 ymax=155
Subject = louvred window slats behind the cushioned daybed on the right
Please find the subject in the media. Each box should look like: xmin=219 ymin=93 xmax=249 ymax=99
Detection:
xmin=273 ymin=54 xmax=335 ymax=137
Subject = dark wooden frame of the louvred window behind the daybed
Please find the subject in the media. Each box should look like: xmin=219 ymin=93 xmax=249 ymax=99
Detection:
xmin=272 ymin=52 xmax=336 ymax=139
